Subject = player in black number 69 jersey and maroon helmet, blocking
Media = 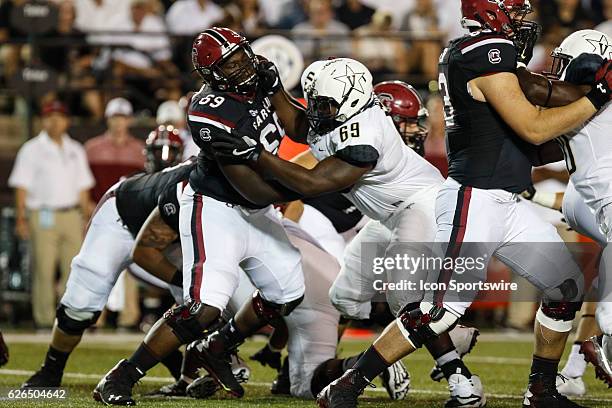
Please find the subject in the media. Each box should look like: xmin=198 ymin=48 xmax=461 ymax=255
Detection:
xmin=96 ymin=27 xmax=304 ymax=405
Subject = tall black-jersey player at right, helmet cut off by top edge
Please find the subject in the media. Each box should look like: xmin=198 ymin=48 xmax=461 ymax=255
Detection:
xmin=320 ymin=0 xmax=612 ymax=408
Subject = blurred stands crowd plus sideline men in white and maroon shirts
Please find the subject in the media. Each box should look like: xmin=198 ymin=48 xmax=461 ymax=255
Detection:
xmin=0 ymin=0 xmax=612 ymax=328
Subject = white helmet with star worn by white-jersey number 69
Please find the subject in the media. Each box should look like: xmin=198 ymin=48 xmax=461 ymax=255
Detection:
xmin=302 ymin=58 xmax=374 ymax=134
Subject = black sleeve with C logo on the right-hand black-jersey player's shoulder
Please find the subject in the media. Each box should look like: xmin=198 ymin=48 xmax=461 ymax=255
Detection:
xmin=459 ymin=37 xmax=516 ymax=81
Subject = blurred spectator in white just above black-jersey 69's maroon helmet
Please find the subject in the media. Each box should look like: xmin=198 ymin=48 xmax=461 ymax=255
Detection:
xmin=166 ymin=0 xmax=223 ymax=34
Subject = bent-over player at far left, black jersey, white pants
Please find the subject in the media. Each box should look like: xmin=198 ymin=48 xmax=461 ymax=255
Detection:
xmin=23 ymin=126 xmax=189 ymax=388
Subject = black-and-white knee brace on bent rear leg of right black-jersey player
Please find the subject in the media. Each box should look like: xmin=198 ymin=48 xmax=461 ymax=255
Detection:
xmin=396 ymin=302 xmax=459 ymax=348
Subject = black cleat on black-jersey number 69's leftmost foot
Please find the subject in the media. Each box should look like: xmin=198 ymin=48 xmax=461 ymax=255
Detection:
xmin=93 ymin=359 xmax=144 ymax=405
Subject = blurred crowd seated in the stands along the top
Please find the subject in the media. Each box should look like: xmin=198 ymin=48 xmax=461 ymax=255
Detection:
xmin=0 ymin=0 xmax=612 ymax=120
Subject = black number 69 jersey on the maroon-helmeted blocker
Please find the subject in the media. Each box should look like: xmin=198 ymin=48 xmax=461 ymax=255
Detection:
xmin=188 ymin=86 xmax=285 ymax=208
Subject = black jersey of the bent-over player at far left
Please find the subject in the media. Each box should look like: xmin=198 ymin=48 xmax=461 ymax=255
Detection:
xmin=115 ymin=158 xmax=196 ymax=237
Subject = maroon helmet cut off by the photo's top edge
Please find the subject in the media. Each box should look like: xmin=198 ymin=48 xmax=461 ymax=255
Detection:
xmin=461 ymin=0 xmax=534 ymax=36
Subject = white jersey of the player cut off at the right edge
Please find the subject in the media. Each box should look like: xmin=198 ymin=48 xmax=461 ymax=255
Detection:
xmin=557 ymin=103 xmax=612 ymax=213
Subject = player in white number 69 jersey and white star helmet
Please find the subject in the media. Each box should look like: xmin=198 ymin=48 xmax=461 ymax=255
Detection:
xmin=212 ymin=58 xmax=485 ymax=406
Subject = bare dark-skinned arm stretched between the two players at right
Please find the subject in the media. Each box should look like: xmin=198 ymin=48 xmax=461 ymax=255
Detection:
xmin=516 ymin=68 xmax=589 ymax=108
